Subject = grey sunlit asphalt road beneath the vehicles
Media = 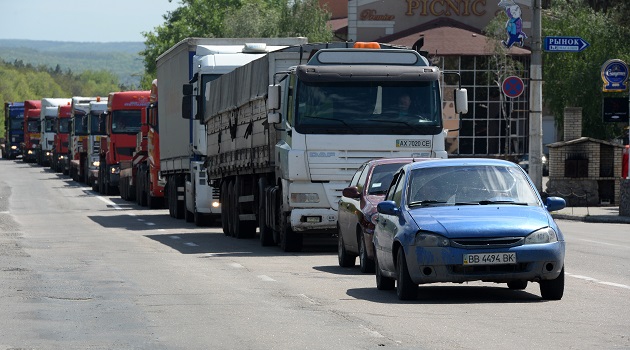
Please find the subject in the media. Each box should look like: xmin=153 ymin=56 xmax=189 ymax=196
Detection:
xmin=0 ymin=160 xmax=630 ymax=349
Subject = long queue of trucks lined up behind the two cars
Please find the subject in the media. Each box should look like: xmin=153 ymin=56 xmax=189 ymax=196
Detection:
xmin=5 ymin=38 xmax=467 ymax=251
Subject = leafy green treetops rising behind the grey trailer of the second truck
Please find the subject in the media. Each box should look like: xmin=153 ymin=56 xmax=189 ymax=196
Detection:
xmin=140 ymin=0 xmax=333 ymax=76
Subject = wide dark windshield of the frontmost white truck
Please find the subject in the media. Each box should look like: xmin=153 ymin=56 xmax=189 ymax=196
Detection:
xmin=295 ymin=81 xmax=442 ymax=135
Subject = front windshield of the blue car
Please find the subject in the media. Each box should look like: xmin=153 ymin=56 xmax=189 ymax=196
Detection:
xmin=407 ymin=165 xmax=540 ymax=206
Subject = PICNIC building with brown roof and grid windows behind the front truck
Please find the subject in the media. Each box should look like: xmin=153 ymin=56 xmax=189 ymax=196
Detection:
xmin=322 ymin=0 xmax=532 ymax=159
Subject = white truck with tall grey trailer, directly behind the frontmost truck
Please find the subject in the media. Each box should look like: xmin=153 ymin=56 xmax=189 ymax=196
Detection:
xmin=156 ymin=38 xmax=306 ymax=225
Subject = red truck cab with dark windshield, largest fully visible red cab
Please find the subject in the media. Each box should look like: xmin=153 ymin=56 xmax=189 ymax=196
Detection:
xmin=98 ymin=91 xmax=150 ymax=195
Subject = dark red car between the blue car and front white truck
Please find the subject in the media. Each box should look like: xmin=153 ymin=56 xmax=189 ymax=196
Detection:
xmin=337 ymin=158 xmax=425 ymax=272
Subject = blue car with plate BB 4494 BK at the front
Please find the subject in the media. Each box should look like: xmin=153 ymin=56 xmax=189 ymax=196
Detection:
xmin=373 ymin=158 xmax=566 ymax=300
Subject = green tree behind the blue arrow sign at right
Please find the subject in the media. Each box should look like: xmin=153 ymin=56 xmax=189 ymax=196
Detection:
xmin=542 ymin=0 xmax=630 ymax=140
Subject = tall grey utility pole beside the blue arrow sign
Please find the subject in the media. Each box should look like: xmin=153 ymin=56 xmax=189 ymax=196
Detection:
xmin=529 ymin=0 xmax=544 ymax=192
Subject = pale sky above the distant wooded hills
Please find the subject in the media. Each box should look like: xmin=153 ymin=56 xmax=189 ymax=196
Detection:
xmin=0 ymin=0 xmax=181 ymax=42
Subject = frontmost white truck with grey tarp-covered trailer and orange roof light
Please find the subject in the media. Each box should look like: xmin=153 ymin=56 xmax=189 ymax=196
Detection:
xmin=202 ymin=43 xmax=467 ymax=251
